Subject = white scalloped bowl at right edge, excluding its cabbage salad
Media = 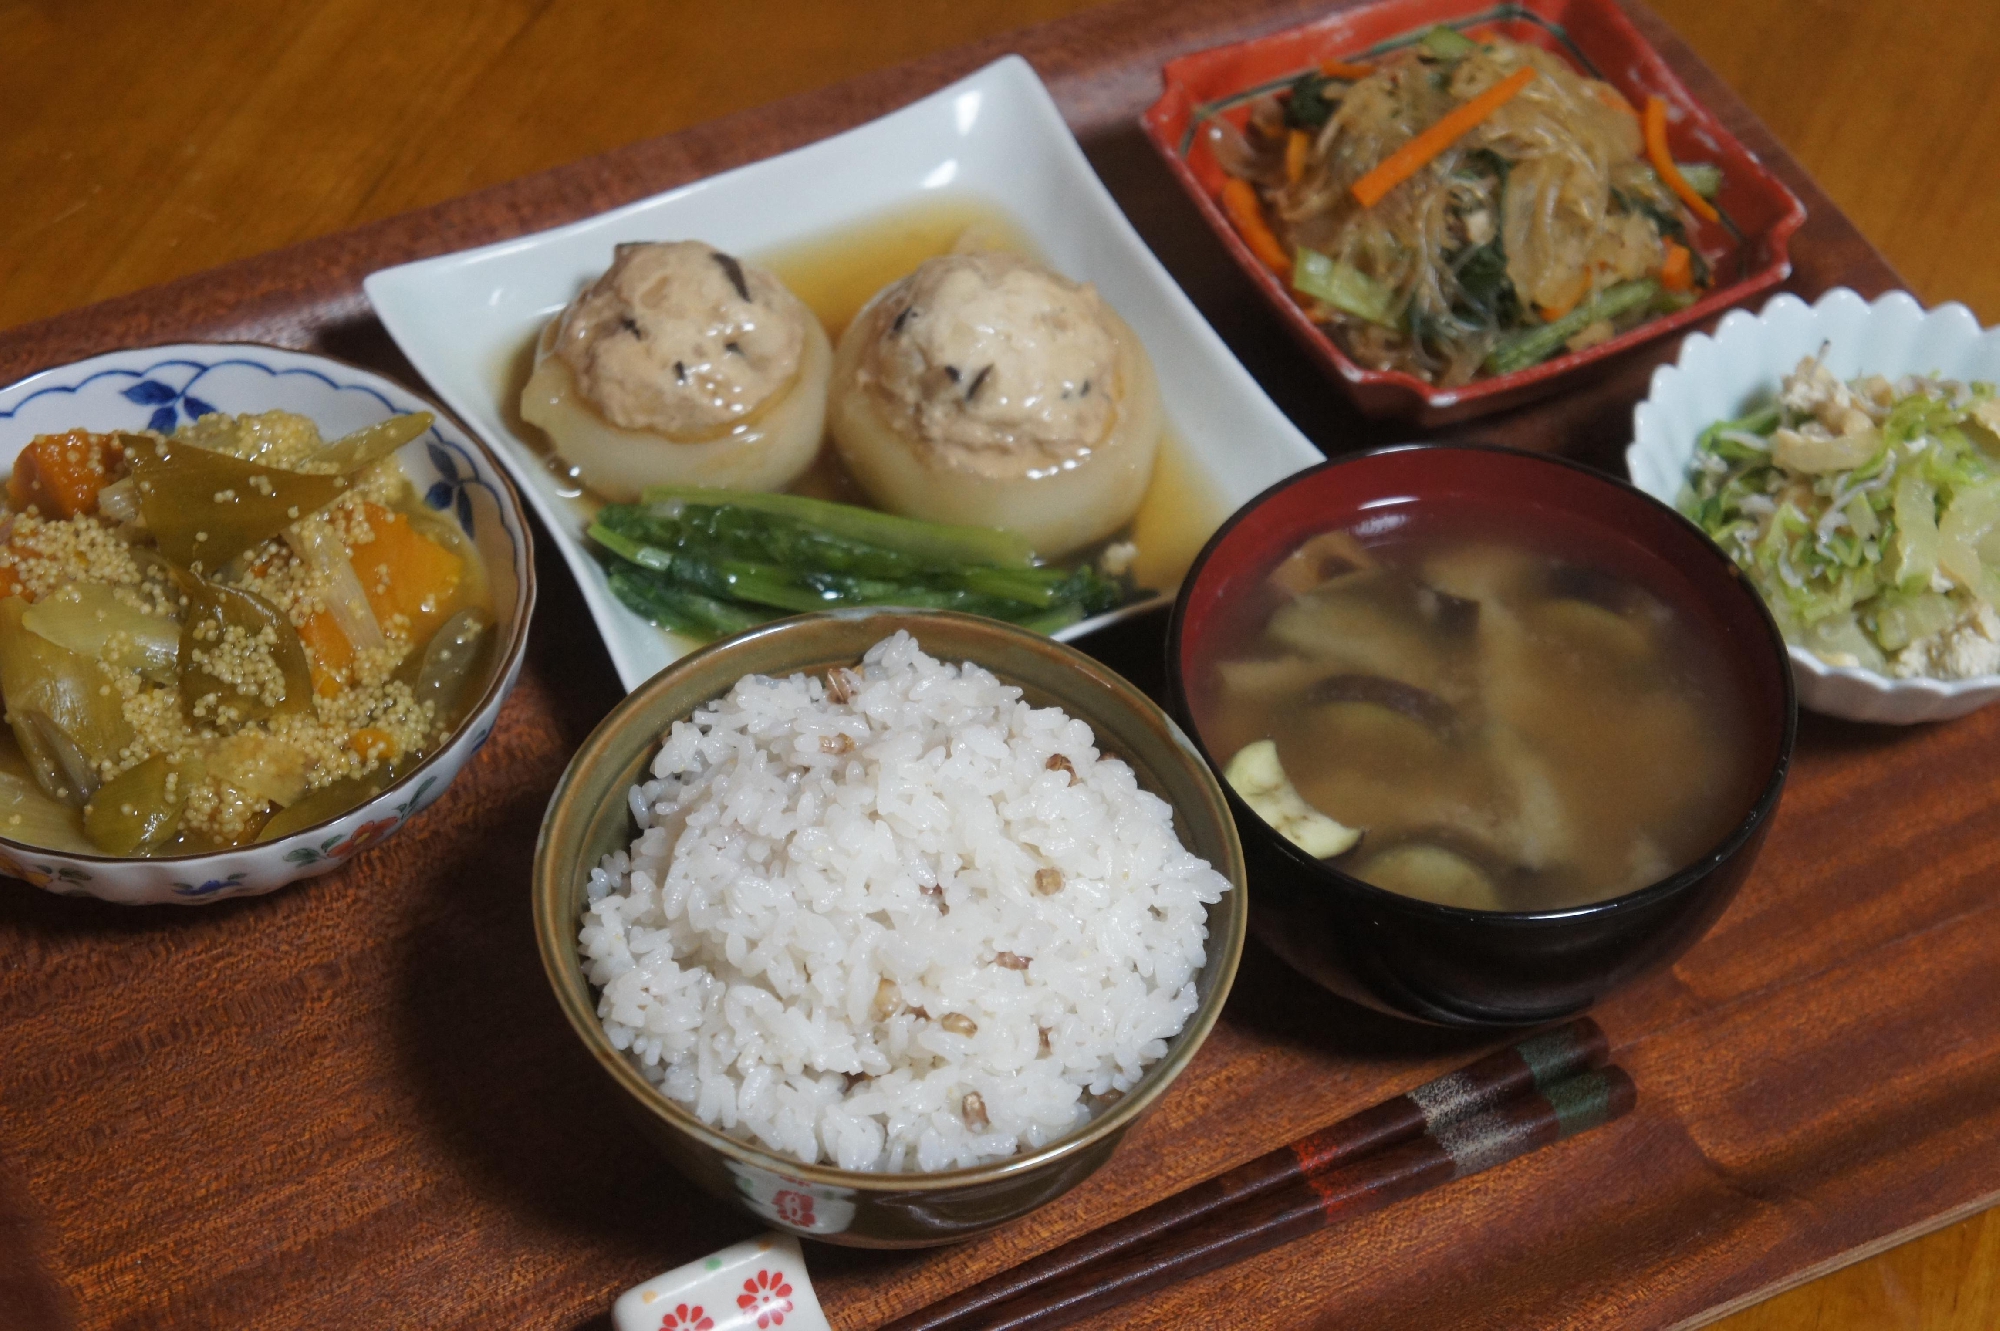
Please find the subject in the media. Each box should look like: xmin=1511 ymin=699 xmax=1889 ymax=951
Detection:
xmin=1626 ymin=286 xmax=2000 ymax=725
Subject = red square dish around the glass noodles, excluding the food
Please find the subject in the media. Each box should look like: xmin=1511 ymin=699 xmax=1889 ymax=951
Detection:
xmin=1144 ymin=0 xmax=1806 ymax=426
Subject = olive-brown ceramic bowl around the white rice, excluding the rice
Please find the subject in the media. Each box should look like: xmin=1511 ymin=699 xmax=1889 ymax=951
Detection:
xmin=534 ymin=610 xmax=1248 ymax=1247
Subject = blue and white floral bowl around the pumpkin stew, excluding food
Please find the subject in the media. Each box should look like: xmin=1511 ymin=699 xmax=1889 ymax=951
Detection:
xmin=0 ymin=342 xmax=534 ymax=905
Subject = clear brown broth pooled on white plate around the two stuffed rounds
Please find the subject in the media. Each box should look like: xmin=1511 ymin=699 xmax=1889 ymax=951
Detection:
xmin=496 ymin=194 xmax=1228 ymax=595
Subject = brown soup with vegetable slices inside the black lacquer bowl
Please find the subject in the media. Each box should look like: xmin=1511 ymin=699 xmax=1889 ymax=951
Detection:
xmin=1190 ymin=504 xmax=1762 ymax=909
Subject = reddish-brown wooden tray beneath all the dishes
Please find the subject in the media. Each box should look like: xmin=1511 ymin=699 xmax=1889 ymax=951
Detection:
xmin=0 ymin=0 xmax=1968 ymax=1329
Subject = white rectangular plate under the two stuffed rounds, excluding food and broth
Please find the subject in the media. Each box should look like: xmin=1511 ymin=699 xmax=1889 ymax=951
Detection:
xmin=366 ymin=56 xmax=1322 ymax=689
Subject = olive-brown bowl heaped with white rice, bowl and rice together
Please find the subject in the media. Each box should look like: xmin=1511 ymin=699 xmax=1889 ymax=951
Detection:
xmin=534 ymin=610 xmax=1248 ymax=1247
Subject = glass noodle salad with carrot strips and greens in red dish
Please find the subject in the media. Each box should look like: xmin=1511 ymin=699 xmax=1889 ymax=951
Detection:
xmin=1208 ymin=26 xmax=1722 ymax=386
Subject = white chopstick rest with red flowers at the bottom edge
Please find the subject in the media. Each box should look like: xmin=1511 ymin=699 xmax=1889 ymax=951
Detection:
xmin=612 ymin=1233 xmax=832 ymax=1331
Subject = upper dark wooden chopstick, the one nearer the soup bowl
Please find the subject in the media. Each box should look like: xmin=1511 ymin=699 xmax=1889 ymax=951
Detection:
xmin=882 ymin=1017 xmax=1608 ymax=1331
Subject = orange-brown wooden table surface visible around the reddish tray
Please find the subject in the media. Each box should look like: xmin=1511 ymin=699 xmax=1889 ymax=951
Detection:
xmin=11 ymin=0 xmax=2000 ymax=1331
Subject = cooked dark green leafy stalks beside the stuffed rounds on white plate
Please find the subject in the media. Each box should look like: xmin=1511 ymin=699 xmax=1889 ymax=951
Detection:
xmin=590 ymin=490 xmax=1120 ymax=638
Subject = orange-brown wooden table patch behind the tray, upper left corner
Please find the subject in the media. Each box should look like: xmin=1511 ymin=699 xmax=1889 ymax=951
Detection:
xmin=0 ymin=0 xmax=1112 ymax=328
